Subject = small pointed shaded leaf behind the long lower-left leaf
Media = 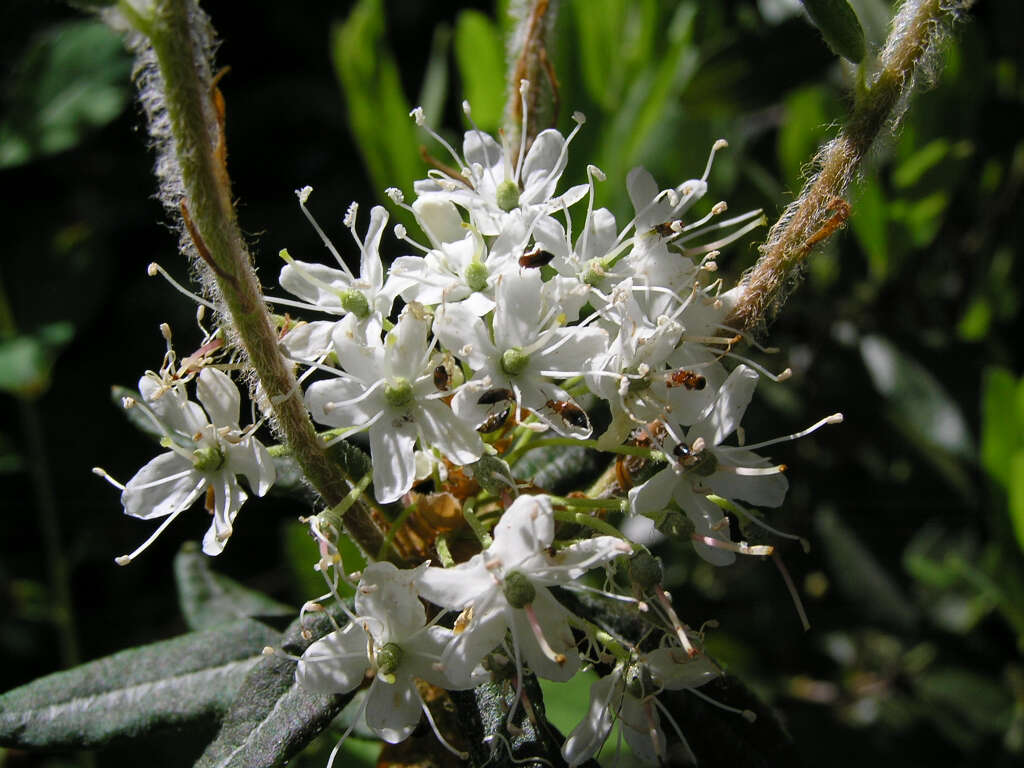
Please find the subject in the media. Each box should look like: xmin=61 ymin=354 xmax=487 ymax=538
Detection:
xmin=174 ymin=542 xmax=295 ymax=630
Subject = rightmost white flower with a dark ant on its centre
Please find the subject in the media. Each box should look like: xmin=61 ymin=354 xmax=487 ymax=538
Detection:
xmin=630 ymin=366 xmax=788 ymax=565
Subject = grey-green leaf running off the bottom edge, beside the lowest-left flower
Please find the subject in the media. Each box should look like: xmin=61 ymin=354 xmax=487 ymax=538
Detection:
xmin=196 ymin=615 xmax=351 ymax=768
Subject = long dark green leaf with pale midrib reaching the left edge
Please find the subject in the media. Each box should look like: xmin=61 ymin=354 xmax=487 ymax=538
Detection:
xmin=0 ymin=620 xmax=281 ymax=749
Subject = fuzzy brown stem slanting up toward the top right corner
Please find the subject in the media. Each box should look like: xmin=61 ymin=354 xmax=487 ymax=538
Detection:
xmin=727 ymin=0 xmax=973 ymax=332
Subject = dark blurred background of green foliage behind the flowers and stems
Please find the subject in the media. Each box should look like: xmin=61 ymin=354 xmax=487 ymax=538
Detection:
xmin=0 ymin=0 xmax=1024 ymax=768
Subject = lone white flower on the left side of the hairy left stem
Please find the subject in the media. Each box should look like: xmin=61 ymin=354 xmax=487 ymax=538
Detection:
xmin=118 ymin=368 xmax=275 ymax=564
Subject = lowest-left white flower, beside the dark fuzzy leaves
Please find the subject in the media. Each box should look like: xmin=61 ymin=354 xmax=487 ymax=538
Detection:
xmin=295 ymin=562 xmax=482 ymax=743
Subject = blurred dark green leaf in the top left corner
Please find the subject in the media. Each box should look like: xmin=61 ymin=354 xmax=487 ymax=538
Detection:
xmin=0 ymin=20 xmax=131 ymax=168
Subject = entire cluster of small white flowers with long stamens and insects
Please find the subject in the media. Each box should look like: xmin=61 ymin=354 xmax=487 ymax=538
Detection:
xmin=99 ymin=88 xmax=839 ymax=765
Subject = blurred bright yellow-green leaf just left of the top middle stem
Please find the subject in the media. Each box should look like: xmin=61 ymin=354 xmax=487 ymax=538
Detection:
xmin=455 ymin=10 xmax=505 ymax=132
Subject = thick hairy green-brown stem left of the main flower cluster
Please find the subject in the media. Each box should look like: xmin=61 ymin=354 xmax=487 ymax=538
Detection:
xmin=110 ymin=0 xmax=383 ymax=554
